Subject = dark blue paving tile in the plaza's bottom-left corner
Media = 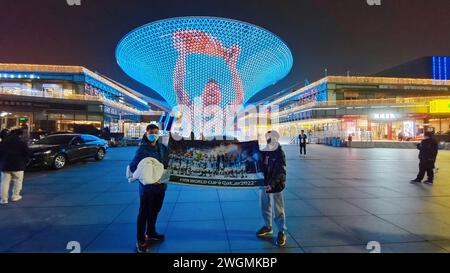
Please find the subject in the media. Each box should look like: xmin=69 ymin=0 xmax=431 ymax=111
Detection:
xmin=0 ymin=223 xmax=48 ymax=252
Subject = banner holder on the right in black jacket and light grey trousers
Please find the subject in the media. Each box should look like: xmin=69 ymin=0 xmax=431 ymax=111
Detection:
xmin=256 ymin=131 xmax=287 ymax=246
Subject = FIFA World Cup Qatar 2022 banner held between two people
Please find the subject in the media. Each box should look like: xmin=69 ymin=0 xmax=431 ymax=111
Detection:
xmin=167 ymin=139 xmax=264 ymax=187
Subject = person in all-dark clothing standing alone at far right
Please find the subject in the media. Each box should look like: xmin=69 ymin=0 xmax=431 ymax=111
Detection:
xmin=411 ymin=132 xmax=439 ymax=185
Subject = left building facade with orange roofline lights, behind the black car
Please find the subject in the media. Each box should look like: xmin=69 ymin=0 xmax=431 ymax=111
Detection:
xmin=0 ymin=64 xmax=165 ymax=137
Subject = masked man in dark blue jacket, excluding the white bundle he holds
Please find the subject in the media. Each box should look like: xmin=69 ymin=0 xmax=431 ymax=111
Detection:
xmin=129 ymin=124 xmax=167 ymax=253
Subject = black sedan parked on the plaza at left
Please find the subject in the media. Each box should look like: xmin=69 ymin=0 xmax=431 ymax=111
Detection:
xmin=28 ymin=134 xmax=108 ymax=170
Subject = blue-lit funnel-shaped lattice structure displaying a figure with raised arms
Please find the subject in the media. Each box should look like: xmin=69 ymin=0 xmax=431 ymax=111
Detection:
xmin=116 ymin=17 xmax=293 ymax=135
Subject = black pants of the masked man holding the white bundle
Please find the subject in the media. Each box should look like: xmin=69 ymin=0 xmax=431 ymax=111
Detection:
xmin=137 ymin=183 xmax=166 ymax=244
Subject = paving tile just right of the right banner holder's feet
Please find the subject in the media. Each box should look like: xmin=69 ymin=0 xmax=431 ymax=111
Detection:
xmin=286 ymin=217 xmax=366 ymax=248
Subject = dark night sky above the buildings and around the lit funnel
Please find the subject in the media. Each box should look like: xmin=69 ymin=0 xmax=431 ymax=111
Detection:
xmin=0 ymin=0 xmax=450 ymax=103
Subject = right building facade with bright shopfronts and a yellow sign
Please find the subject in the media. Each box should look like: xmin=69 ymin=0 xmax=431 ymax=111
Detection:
xmin=265 ymin=76 xmax=450 ymax=141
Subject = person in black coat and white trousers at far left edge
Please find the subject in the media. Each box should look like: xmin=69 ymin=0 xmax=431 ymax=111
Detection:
xmin=0 ymin=129 xmax=30 ymax=204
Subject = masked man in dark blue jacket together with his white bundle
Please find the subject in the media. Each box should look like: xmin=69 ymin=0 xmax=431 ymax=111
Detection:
xmin=129 ymin=124 xmax=167 ymax=253
